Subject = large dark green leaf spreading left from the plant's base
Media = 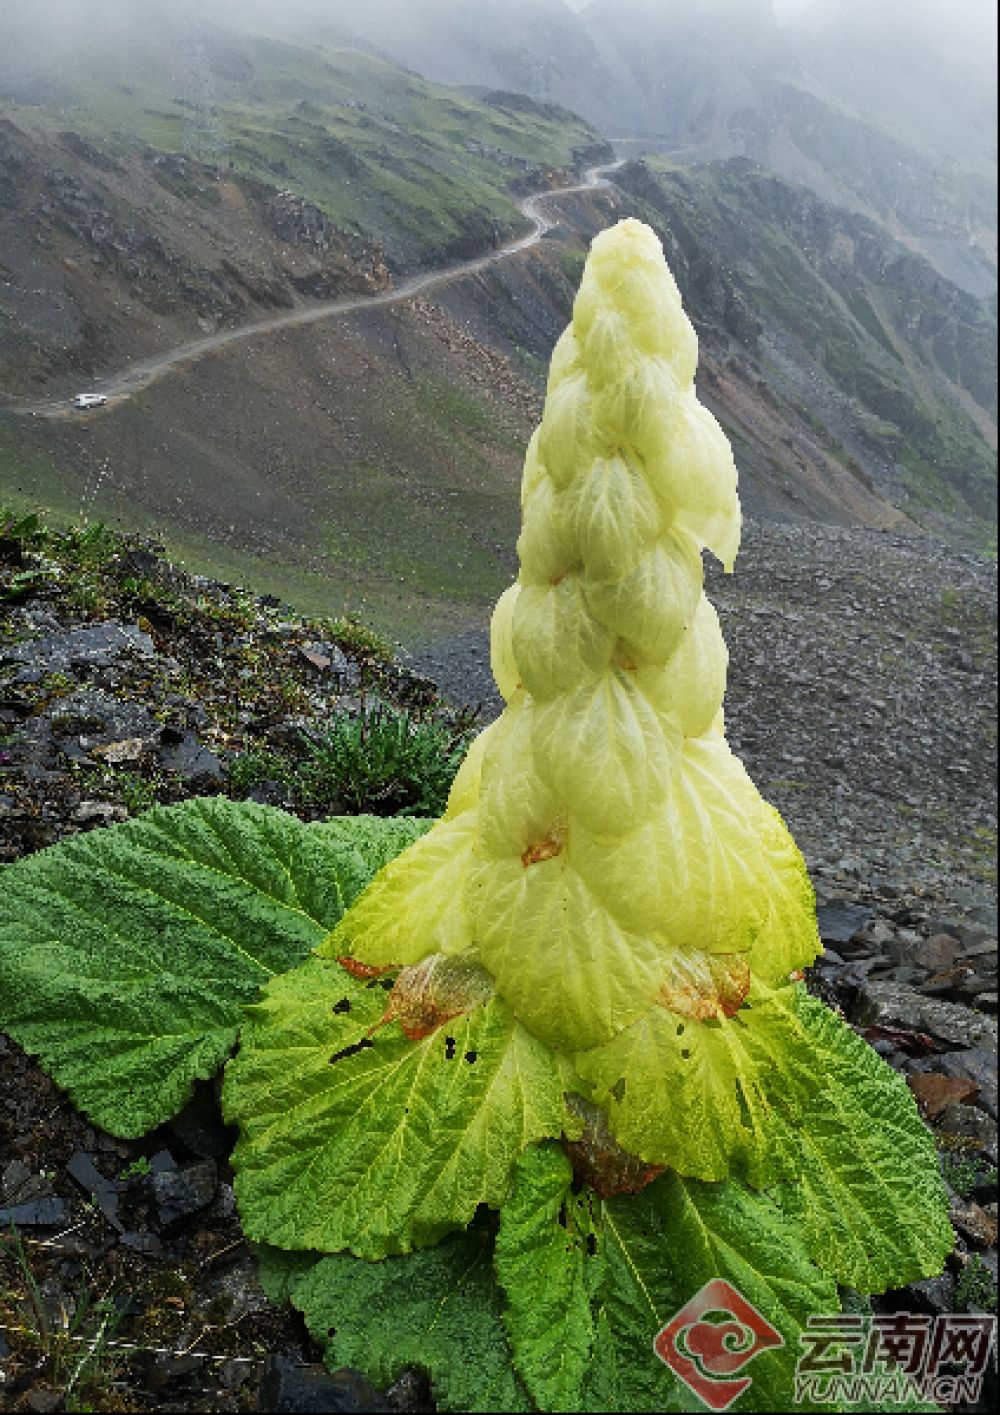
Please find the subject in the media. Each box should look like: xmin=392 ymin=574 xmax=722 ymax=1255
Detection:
xmin=0 ymin=798 xmax=371 ymax=1136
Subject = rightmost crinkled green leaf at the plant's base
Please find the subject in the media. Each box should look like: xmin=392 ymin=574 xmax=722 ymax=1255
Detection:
xmin=775 ymin=993 xmax=955 ymax=1292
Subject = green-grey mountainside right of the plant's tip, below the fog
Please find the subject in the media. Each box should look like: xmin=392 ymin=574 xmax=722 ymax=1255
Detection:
xmin=617 ymin=158 xmax=997 ymax=526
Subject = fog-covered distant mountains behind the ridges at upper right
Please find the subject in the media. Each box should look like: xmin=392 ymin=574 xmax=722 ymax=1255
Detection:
xmin=229 ymin=0 xmax=997 ymax=294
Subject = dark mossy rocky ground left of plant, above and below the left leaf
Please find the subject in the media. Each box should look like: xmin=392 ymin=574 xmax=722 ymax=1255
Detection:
xmin=0 ymin=514 xmax=453 ymax=1412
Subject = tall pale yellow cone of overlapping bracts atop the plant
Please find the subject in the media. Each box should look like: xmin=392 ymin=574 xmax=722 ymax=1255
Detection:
xmin=324 ymin=221 xmax=818 ymax=1064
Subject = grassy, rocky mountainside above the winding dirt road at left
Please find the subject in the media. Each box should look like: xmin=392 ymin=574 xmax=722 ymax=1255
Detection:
xmin=0 ymin=6 xmax=603 ymax=393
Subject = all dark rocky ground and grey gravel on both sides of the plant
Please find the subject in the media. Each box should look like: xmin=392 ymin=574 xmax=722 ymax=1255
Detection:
xmin=0 ymin=524 xmax=997 ymax=1411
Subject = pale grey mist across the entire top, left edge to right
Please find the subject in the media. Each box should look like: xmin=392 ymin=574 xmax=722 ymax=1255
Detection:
xmin=0 ymin=0 xmax=997 ymax=290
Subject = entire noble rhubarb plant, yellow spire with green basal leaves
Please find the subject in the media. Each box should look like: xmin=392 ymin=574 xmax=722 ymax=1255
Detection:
xmin=0 ymin=221 xmax=952 ymax=1411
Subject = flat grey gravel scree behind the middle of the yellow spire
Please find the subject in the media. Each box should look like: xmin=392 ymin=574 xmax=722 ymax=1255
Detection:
xmin=409 ymin=522 xmax=997 ymax=908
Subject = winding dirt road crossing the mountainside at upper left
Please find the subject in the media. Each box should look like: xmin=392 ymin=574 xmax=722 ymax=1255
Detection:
xmin=0 ymin=161 xmax=621 ymax=419
